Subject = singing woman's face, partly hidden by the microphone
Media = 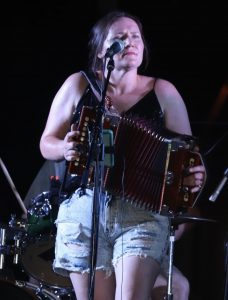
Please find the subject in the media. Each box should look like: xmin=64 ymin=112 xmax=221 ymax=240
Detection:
xmin=100 ymin=17 xmax=144 ymax=69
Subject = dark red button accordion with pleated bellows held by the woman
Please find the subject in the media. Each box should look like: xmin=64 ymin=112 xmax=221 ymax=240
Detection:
xmin=69 ymin=107 xmax=203 ymax=214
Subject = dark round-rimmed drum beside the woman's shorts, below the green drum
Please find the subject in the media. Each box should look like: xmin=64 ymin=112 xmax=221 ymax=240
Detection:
xmin=21 ymin=235 xmax=73 ymax=294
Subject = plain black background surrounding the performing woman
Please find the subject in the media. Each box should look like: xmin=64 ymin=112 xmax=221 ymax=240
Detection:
xmin=0 ymin=0 xmax=228 ymax=300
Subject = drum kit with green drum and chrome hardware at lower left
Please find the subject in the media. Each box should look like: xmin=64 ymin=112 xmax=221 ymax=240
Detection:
xmin=0 ymin=192 xmax=76 ymax=300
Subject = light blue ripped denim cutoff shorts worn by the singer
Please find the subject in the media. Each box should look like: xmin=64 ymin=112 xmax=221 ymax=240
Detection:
xmin=53 ymin=189 xmax=169 ymax=276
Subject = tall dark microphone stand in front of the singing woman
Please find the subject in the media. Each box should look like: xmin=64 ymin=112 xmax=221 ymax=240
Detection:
xmin=80 ymin=56 xmax=114 ymax=300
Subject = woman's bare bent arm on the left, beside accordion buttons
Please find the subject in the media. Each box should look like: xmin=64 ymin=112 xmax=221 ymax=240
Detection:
xmin=40 ymin=73 xmax=87 ymax=160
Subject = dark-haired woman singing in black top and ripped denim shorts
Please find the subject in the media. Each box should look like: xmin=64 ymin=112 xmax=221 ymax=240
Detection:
xmin=40 ymin=11 xmax=204 ymax=300
